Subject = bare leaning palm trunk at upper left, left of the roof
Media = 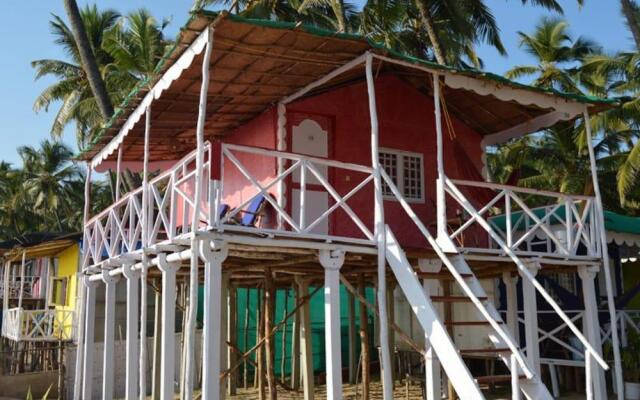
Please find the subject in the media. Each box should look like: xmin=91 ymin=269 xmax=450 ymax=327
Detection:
xmin=64 ymin=0 xmax=113 ymax=120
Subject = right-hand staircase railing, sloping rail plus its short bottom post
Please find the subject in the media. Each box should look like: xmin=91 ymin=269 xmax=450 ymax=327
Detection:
xmin=444 ymin=177 xmax=609 ymax=399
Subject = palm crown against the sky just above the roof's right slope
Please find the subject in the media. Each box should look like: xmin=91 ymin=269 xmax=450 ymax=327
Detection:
xmin=506 ymin=18 xmax=600 ymax=93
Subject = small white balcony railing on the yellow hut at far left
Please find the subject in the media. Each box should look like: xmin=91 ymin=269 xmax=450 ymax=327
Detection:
xmin=2 ymin=308 xmax=75 ymax=342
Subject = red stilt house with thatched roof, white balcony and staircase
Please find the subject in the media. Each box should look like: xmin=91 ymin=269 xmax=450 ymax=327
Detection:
xmin=75 ymin=12 xmax=622 ymax=400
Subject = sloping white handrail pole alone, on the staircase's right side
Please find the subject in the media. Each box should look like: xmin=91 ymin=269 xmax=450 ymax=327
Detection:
xmin=444 ymin=177 xmax=609 ymax=371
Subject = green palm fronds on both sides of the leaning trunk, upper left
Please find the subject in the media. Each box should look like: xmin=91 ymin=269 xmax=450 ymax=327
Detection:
xmin=31 ymin=5 xmax=169 ymax=150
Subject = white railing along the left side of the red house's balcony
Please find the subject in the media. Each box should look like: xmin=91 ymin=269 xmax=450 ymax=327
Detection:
xmin=83 ymin=143 xmax=211 ymax=267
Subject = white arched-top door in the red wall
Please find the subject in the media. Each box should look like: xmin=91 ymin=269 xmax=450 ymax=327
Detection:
xmin=291 ymin=119 xmax=329 ymax=235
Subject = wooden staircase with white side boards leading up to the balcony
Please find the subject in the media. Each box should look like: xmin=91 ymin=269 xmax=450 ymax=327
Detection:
xmin=386 ymin=227 xmax=553 ymax=400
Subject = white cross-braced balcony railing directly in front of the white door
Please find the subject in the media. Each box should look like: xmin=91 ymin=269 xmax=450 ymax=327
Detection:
xmin=212 ymin=144 xmax=374 ymax=244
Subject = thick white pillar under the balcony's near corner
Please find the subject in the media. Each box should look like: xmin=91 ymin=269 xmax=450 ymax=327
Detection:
xmin=201 ymin=241 xmax=228 ymax=400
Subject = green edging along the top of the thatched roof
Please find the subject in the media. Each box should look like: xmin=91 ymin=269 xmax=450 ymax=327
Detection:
xmin=78 ymin=10 xmax=626 ymax=158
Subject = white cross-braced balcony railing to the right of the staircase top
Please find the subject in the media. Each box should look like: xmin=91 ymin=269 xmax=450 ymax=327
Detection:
xmin=445 ymin=178 xmax=601 ymax=257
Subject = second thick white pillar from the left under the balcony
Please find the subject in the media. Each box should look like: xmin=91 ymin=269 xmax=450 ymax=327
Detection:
xmin=102 ymin=269 xmax=120 ymax=400
